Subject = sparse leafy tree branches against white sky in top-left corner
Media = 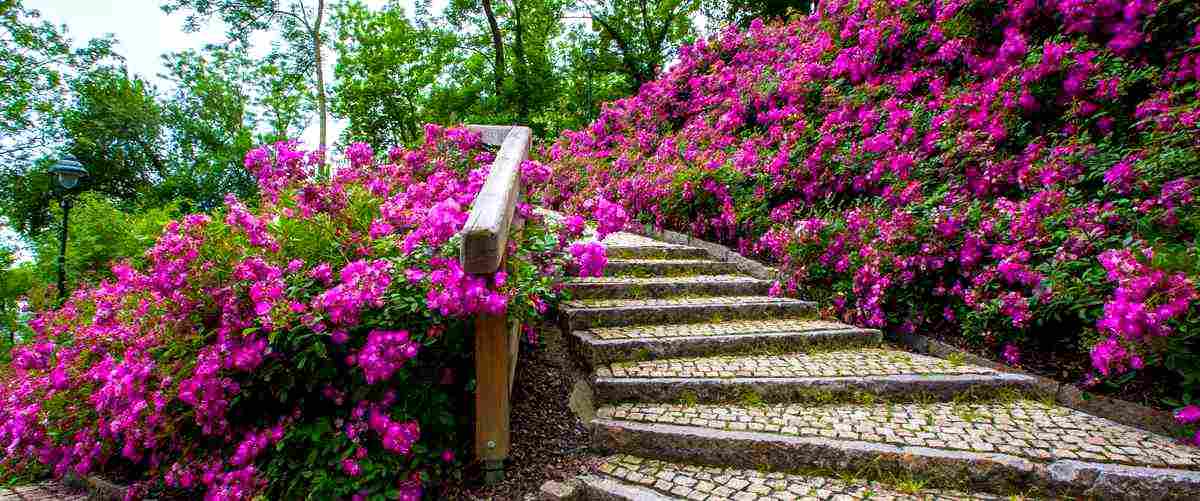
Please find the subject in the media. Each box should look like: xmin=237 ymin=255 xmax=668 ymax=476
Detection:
xmin=0 ymin=0 xmax=113 ymax=169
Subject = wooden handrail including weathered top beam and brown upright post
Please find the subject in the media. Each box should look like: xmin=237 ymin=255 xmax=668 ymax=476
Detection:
xmin=460 ymin=126 xmax=533 ymax=483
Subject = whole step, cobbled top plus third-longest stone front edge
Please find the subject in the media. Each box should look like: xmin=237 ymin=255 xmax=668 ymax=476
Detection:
xmin=568 ymin=319 xmax=882 ymax=367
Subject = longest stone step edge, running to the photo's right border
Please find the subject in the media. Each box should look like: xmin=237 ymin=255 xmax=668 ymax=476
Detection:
xmin=590 ymin=418 xmax=1200 ymax=500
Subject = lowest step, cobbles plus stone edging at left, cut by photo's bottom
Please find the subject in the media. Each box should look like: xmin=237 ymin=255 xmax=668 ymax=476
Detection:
xmin=556 ymin=454 xmax=1009 ymax=501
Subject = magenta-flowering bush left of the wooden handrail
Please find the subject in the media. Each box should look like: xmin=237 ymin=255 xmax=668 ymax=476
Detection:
xmin=0 ymin=126 xmax=578 ymax=499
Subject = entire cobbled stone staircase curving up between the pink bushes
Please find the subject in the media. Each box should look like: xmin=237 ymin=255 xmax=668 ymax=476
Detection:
xmin=542 ymin=234 xmax=1200 ymax=501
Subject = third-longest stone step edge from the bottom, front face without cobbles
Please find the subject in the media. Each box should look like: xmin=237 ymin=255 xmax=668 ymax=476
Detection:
xmin=568 ymin=326 xmax=883 ymax=367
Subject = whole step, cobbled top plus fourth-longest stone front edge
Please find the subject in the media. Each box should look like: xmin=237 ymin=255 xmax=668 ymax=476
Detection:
xmin=560 ymin=296 xmax=815 ymax=332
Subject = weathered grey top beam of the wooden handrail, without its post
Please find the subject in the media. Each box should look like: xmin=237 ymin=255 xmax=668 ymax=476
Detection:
xmin=461 ymin=127 xmax=532 ymax=274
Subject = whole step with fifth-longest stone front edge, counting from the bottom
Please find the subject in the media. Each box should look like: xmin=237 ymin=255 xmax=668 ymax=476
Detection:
xmin=566 ymin=274 xmax=770 ymax=300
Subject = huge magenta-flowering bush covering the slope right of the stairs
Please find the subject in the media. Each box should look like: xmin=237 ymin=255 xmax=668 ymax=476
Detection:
xmin=544 ymin=0 xmax=1200 ymax=442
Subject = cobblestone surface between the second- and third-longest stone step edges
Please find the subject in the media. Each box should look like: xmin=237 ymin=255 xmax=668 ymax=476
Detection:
xmin=596 ymin=348 xmax=995 ymax=378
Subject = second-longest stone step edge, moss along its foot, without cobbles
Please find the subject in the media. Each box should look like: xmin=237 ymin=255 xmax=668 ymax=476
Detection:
xmin=593 ymin=369 xmax=1034 ymax=404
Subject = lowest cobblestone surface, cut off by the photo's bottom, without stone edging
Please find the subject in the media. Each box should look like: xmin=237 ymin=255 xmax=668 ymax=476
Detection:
xmin=599 ymin=455 xmax=1008 ymax=501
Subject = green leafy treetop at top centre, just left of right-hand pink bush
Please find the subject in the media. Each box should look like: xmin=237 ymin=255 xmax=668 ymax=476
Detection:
xmin=578 ymin=0 xmax=701 ymax=91
